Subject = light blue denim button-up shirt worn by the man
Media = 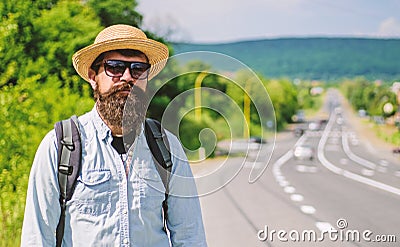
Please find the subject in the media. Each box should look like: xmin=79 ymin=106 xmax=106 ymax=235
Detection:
xmin=21 ymin=107 xmax=207 ymax=247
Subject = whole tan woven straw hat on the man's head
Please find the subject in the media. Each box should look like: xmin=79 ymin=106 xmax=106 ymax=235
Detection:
xmin=72 ymin=24 xmax=168 ymax=81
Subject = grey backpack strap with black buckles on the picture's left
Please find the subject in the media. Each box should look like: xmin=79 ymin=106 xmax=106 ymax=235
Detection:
xmin=54 ymin=115 xmax=82 ymax=247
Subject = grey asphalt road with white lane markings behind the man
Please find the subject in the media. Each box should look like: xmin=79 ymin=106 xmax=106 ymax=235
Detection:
xmin=193 ymin=91 xmax=400 ymax=247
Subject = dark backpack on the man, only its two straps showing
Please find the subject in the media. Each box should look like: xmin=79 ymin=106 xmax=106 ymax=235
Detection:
xmin=54 ymin=115 xmax=172 ymax=247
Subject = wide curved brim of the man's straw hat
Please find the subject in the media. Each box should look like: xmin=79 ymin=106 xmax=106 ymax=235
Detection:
xmin=72 ymin=38 xmax=169 ymax=82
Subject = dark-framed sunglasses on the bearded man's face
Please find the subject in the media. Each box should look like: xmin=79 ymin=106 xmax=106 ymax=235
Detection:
xmin=104 ymin=60 xmax=151 ymax=80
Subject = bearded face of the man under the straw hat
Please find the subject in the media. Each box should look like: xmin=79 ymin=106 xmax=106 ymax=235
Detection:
xmin=89 ymin=52 xmax=147 ymax=129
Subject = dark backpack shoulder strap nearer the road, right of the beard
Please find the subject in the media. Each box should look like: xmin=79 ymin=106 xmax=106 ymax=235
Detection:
xmin=145 ymin=118 xmax=172 ymax=231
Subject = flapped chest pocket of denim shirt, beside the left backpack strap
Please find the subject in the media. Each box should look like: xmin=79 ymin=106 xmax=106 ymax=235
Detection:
xmin=74 ymin=170 xmax=111 ymax=216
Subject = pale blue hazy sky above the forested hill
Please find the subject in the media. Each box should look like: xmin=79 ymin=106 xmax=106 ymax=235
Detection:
xmin=137 ymin=0 xmax=400 ymax=43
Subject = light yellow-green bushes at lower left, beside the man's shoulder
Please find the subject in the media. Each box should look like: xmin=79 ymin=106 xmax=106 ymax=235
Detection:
xmin=0 ymin=76 xmax=93 ymax=246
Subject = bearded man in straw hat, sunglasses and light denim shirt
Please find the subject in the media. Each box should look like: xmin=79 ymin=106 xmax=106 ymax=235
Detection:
xmin=22 ymin=25 xmax=207 ymax=246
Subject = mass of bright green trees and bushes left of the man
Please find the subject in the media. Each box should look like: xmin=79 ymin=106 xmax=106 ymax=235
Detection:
xmin=0 ymin=0 xmax=122 ymax=243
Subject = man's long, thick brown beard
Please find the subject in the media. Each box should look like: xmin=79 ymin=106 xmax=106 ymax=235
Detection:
xmin=94 ymin=84 xmax=148 ymax=136
